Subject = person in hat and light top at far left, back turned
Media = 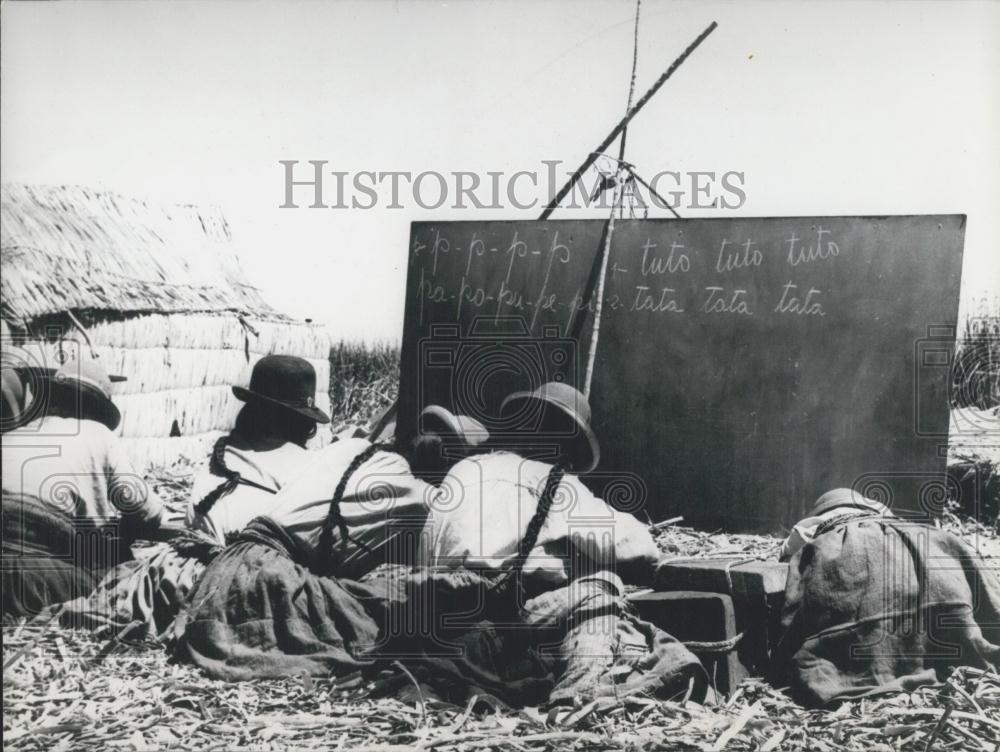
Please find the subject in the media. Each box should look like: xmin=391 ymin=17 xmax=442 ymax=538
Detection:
xmin=2 ymin=360 xmax=163 ymax=615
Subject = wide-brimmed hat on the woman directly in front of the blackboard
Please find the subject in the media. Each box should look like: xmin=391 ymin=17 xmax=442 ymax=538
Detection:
xmin=500 ymin=381 xmax=601 ymax=473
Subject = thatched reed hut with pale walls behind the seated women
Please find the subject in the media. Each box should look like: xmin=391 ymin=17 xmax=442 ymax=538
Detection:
xmin=0 ymin=185 xmax=330 ymax=468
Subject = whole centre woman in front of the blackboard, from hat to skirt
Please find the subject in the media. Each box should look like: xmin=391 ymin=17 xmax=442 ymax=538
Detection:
xmin=390 ymin=383 xmax=707 ymax=705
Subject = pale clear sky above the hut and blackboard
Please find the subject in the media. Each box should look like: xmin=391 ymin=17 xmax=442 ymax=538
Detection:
xmin=0 ymin=0 xmax=1000 ymax=341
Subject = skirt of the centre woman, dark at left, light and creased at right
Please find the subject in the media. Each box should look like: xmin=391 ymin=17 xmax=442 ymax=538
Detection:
xmin=379 ymin=569 xmax=707 ymax=707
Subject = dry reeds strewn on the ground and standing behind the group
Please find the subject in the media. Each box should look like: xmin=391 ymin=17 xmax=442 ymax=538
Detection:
xmin=3 ymin=340 xmax=1000 ymax=752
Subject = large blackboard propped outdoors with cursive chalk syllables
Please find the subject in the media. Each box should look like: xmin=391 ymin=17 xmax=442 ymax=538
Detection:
xmin=397 ymin=215 xmax=965 ymax=531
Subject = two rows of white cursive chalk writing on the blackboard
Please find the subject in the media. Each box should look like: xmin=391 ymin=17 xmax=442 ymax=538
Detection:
xmin=412 ymin=226 xmax=841 ymax=328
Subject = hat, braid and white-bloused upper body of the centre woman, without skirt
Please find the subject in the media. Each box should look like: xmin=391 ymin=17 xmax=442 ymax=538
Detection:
xmin=418 ymin=382 xmax=660 ymax=593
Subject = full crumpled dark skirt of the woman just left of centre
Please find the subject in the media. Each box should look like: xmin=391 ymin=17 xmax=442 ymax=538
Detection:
xmin=174 ymin=517 xmax=402 ymax=681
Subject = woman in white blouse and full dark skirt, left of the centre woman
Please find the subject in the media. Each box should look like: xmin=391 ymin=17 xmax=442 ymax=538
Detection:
xmin=175 ymin=413 xmax=481 ymax=680
